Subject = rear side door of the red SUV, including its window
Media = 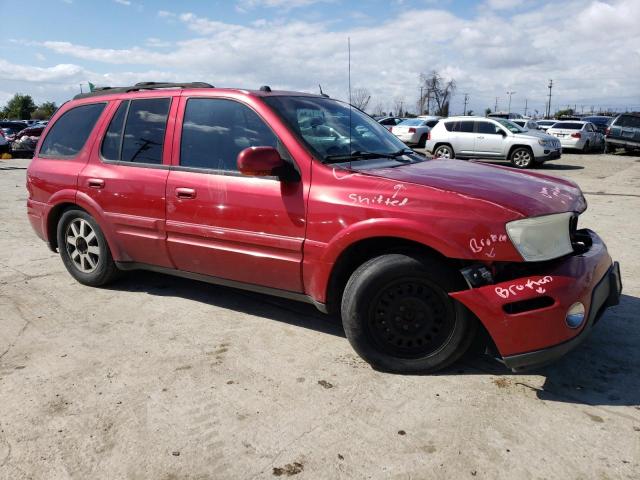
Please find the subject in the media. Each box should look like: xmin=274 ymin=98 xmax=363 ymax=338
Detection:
xmin=78 ymin=93 xmax=177 ymax=267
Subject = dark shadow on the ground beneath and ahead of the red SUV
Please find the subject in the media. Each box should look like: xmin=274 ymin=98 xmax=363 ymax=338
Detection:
xmin=108 ymin=271 xmax=640 ymax=406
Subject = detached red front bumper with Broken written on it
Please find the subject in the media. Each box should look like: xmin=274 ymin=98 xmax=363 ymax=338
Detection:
xmin=450 ymin=230 xmax=621 ymax=369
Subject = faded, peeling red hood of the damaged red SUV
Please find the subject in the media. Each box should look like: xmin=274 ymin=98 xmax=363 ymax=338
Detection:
xmin=362 ymin=159 xmax=587 ymax=217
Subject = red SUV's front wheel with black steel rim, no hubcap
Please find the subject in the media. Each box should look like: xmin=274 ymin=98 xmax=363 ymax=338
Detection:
xmin=342 ymin=254 xmax=477 ymax=373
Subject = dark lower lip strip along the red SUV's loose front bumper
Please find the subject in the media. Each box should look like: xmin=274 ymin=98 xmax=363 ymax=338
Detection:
xmin=502 ymin=262 xmax=622 ymax=372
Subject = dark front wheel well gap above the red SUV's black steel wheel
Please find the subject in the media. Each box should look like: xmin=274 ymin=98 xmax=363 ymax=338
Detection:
xmin=326 ymin=237 xmax=464 ymax=314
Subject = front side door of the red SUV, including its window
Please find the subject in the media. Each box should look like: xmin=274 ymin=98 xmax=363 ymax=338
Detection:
xmin=167 ymin=97 xmax=305 ymax=292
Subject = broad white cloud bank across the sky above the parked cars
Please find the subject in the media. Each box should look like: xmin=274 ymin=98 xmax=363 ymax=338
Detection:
xmin=5 ymin=0 xmax=640 ymax=112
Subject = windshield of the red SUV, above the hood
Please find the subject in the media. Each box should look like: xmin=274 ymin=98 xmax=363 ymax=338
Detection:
xmin=264 ymin=96 xmax=408 ymax=161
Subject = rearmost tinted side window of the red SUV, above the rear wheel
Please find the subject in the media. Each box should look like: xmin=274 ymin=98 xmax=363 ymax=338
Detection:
xmin=40 ymin=103 xmax=106 ymax=157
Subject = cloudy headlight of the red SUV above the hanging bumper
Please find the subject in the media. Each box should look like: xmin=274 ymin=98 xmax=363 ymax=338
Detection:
xmin=506 ymin=212 xmax=573 ymax=262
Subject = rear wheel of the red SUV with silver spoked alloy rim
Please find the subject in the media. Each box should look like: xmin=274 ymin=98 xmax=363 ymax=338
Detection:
xmin=57 ymin=209 xmax=119 ymax=287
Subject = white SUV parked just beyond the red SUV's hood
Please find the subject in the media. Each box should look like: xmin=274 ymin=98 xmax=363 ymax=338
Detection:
xmin=425 ymin=117 xmax=562 ymax=168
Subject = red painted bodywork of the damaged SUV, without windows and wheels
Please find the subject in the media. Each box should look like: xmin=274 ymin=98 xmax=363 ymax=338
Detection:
xmin=27 ymin=89 xmax=611 ymax=355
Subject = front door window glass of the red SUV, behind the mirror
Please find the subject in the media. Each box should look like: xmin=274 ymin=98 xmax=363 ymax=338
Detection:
xmin=180 ymin=98 xmax=280 ymax=172
